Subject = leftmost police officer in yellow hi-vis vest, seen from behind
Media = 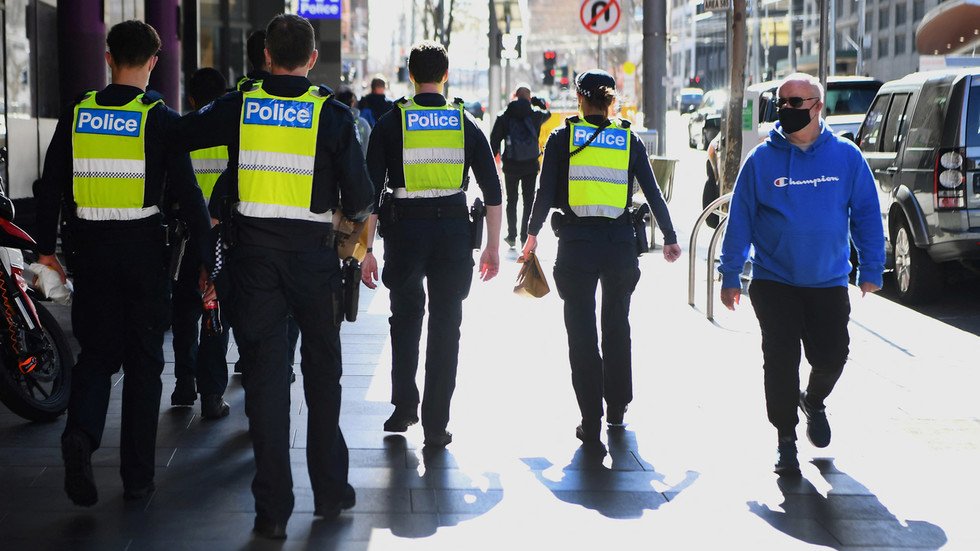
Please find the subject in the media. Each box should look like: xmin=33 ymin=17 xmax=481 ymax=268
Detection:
xmin=35 ymin=21 xmax=210 ymax=506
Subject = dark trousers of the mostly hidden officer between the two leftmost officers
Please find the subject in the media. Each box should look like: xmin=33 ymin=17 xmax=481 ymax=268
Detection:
xmin=171 ymin=262 xmax=231 ymax=396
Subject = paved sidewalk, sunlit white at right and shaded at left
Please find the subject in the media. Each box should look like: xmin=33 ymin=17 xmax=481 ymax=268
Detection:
xmin=0 ymin=227 xmax=980 ymax=551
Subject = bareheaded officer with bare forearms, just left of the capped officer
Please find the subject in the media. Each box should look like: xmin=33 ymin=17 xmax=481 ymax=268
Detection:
xmin=361 ymin=41 xmax=501 ymax=446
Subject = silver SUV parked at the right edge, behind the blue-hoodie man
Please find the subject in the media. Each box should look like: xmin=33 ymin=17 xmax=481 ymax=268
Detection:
xmin=856 ymin=68 xmax=980 ymax=303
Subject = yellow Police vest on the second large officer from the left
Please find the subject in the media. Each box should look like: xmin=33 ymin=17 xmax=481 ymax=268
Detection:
xmin=237 ymin=86 xmax=333 ymax=223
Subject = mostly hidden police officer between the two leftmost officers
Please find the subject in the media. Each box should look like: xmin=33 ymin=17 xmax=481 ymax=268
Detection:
xmin=170 ymin=67 xmax=229 ymax=419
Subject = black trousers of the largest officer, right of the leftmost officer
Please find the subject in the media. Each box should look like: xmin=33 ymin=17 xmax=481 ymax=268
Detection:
xmin=231 ymin=245 xmax=349 ymax=521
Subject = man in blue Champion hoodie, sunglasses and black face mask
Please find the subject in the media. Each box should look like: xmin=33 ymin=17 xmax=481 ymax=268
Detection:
xmin=719 ymin=73 xmax=885 ymax=476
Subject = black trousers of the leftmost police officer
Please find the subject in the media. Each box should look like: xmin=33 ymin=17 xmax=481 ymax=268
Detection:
xmin=65 ymin=236 xmax=170 ymax=489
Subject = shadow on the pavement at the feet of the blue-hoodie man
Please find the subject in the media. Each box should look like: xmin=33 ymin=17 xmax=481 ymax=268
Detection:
xmin=748 ymin=458 xmax=947 ymax=549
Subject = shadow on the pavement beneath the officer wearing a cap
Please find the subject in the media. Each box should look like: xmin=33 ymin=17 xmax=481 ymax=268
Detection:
xmin=522 ymin=428 xmax=699 ymax=519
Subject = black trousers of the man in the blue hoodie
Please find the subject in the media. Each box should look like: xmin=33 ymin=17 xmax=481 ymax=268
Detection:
xmin=749 ymin=280 xmax=851 ymax=439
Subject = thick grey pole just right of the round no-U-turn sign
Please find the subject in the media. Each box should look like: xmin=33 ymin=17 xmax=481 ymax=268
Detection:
xmin=643 ymin=0 xmax=667 ymax=155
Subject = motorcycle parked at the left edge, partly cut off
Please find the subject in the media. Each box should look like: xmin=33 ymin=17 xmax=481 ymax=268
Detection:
xmin=0 ymin=185 xmax=73 ymax=421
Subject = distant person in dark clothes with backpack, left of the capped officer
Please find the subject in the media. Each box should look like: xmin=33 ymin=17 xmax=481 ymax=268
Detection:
xmin=490 ymin=86 xmax=551 ymax=249
